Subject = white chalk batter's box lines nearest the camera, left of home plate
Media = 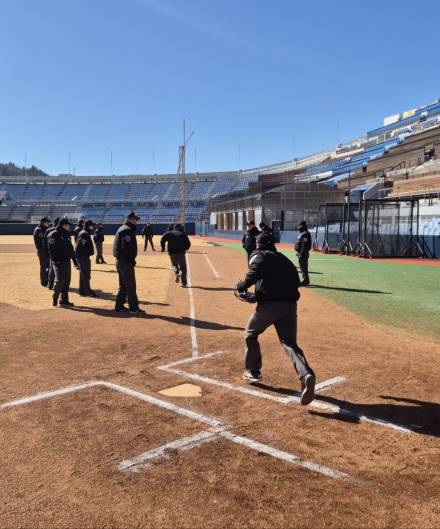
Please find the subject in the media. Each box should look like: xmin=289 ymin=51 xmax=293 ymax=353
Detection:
xmin=0 ymin=380 xmax=372 ymax=487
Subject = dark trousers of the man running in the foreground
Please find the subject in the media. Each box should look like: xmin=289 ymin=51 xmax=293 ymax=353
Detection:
xmin=245 ymin=301 xmax=314 ymax=379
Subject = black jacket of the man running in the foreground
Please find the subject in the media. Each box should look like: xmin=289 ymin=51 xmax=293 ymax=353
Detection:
xmin=237 ymin=250 xmax=300 ymax=303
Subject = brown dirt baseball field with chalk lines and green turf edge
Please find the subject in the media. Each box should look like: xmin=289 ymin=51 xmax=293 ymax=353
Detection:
xmin=0 ymin=236 xmax=440 ymax=529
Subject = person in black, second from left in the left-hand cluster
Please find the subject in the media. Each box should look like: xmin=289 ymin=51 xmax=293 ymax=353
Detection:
xmin=48 ymin=218 xmax=78 ymax=307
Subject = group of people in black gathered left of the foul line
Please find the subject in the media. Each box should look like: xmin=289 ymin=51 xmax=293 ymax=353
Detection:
xmin=33 ymin=212 xmax=191 ymax=314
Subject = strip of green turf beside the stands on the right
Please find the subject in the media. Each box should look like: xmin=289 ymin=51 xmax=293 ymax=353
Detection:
xmin=211 ymin=243 xmax=440 ymax=341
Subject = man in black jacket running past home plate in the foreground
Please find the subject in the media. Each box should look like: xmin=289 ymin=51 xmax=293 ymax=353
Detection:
xmin=236 ymin=233 xmax=315 ymax=405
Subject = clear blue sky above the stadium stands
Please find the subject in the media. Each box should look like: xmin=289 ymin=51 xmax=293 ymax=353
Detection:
xmin=0 ymin=0 xmax=440 ymax=175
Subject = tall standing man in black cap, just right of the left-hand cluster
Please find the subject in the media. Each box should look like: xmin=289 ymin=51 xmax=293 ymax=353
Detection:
xmin=113 ymin=212 xmax=145 ymax=314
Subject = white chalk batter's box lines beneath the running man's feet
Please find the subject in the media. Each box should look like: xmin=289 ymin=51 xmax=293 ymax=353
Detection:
xmin=158 ymin=351 xmax=418 ymax=433
